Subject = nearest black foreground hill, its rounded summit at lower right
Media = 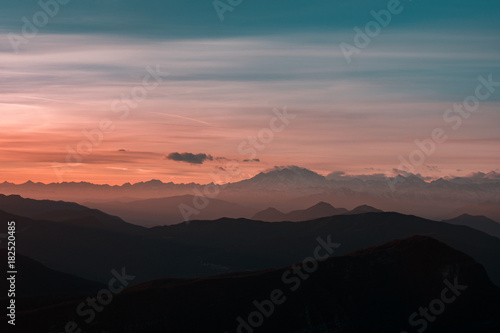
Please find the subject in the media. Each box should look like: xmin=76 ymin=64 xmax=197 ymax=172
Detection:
xmin=12 ymin=237 xmax=500 ymax=333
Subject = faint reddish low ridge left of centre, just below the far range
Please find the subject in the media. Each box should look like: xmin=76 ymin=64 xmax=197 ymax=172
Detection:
xmin=86 ymin=195 xmax=255 ymax=227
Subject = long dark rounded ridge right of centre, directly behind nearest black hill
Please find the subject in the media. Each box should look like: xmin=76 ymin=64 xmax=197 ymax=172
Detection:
xmin=152 ymin=213 xmax=500 ymax=285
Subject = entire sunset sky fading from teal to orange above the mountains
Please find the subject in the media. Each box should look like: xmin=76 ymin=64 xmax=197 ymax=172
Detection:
xmin=0 ymin=0 xmax=500 ymax=184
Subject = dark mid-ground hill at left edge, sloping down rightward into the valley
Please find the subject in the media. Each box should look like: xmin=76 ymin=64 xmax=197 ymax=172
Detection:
xmin=0 ymin=211 xmax=247 ymax=283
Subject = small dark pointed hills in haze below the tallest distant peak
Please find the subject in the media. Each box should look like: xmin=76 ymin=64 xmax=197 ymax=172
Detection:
xmin=252 ymin=202 xmax=348 ymax=222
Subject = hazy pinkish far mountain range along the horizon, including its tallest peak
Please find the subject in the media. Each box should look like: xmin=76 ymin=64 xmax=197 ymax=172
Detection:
xmin=0 ymin=166 xmax=500 ymax=220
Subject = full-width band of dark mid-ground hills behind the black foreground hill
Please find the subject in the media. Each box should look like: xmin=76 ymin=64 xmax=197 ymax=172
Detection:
xmin=0 ymin=195 xmax=500 ymax=284
